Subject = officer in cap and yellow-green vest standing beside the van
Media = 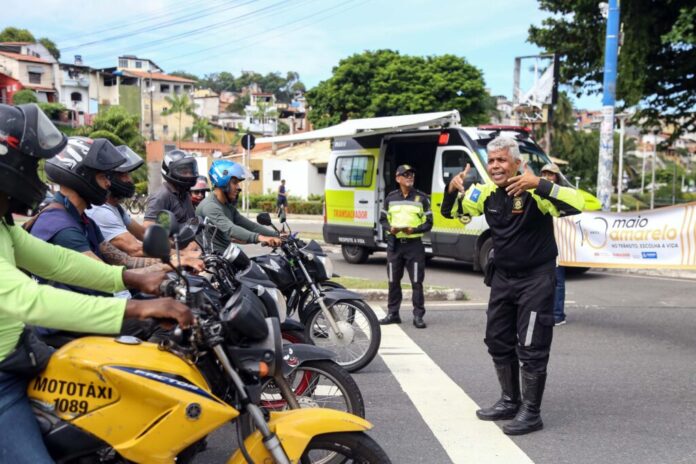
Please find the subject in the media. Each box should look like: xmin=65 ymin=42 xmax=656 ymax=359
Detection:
xmin=379 ymin=164 xmax=433 ymax=329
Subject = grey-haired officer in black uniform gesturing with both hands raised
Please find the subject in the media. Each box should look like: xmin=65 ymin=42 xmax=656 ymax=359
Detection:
xmin=441 ymin=137 xmax=584 ymax=435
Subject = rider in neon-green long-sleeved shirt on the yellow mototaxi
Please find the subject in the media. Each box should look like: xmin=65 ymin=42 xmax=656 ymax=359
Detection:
xmin=0 ymin=105 xmax=192 ymax=464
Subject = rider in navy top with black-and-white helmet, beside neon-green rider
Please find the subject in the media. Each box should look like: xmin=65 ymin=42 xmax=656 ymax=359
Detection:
xmin=26 ymin=137 xmax=169 ymax=276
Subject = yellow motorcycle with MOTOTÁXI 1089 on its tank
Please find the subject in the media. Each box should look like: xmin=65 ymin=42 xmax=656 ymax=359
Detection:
xmin=28 ymin=225 xmax=390 ymax=464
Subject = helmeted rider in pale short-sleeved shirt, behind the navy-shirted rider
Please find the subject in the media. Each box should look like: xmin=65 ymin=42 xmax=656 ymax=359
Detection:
xmin=85 ymin=145 xmax=204 ymax=271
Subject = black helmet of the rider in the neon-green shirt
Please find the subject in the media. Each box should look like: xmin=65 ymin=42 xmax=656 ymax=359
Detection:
xmin=0 ymin=104 xmax=67 ymax=213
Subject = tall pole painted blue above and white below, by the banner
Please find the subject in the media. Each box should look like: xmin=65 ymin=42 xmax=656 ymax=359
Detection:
xmin=597 ymin=0 xmax=620 ymax=211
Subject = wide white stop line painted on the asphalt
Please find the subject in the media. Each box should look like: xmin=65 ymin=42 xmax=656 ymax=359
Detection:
xmin=372 ymin=305 xmax=533 ymax=464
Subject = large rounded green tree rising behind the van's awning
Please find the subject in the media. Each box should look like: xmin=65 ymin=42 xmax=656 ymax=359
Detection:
xmin=306 ymin=50 xmax=491 ymax=127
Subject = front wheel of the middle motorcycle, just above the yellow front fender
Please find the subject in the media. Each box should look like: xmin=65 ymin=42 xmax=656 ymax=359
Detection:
xmin=237 ymin=360 xmax=365 ymax=438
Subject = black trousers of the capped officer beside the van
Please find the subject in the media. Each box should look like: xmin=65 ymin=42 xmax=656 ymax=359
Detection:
xmin=387 ymin=239 xmax=425 ymax=317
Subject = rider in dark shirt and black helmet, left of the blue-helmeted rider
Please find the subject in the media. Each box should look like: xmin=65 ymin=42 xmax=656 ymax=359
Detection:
xmin=145 ymin=150 xmax=198 ymax=227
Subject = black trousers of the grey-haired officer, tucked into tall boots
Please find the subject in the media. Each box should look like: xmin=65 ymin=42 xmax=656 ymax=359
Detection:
xmin=484 ymin=263 xmax=556 ymax=373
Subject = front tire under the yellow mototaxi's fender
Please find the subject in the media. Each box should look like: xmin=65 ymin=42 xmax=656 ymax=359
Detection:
xmin=299 ymin=432 xmax=391 ymax=464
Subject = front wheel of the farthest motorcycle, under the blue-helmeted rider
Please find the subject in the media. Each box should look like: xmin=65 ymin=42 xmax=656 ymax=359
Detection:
xmin=303 ymin=300 xmax=382 ymax=372
